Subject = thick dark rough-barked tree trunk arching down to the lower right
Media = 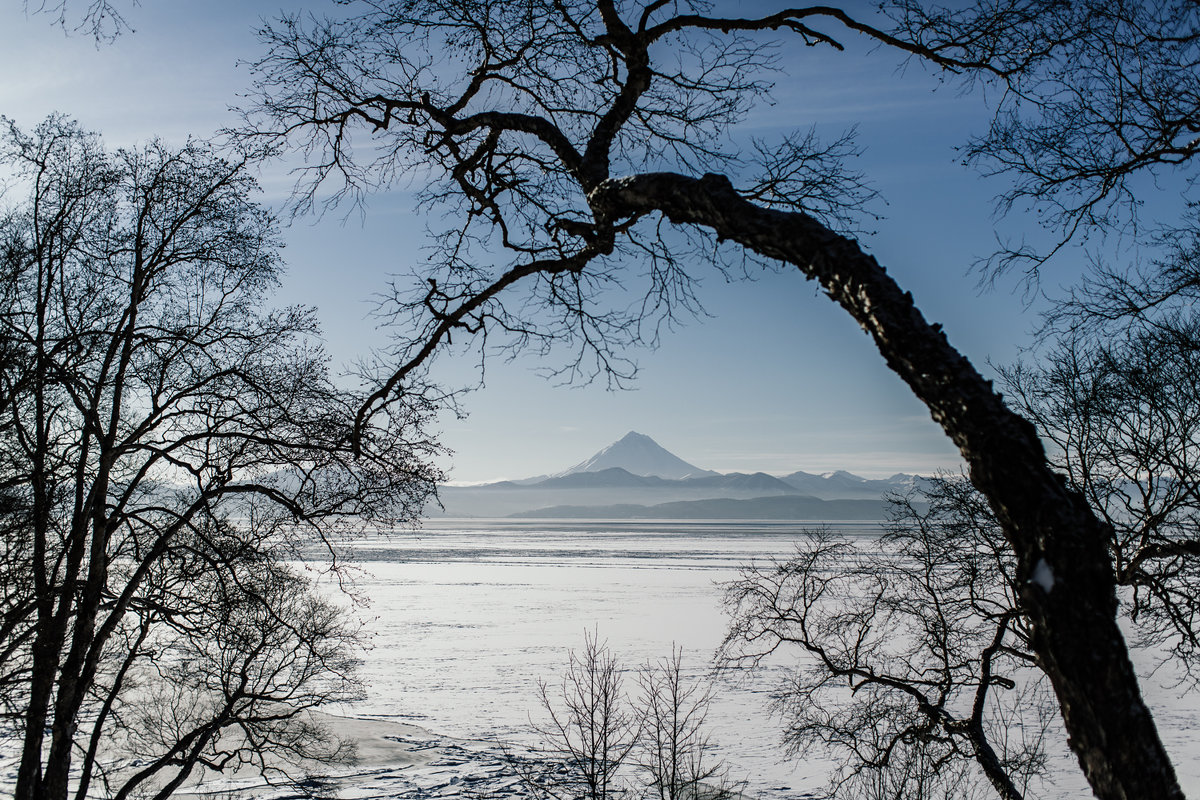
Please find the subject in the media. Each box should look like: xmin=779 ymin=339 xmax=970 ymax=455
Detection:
xmin=589 ymin=173 xmax=1183 ymax=800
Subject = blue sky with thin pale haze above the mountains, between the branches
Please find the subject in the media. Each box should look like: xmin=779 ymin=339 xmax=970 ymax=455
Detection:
xmin=0 ymin=0 xmax=1074 ymax=481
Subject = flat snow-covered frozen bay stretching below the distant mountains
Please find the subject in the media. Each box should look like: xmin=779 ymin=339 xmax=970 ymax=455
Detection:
xmin=319 ymin=519 xmax=1200 ymax=800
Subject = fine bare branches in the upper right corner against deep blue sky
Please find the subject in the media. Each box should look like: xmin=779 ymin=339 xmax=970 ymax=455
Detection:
xmin=955 ymin=0 xmax=1200 ymax=275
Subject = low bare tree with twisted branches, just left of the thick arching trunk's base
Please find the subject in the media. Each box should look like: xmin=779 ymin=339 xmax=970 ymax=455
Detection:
xmin=721 ymin=494 xmax=1049 ymax=800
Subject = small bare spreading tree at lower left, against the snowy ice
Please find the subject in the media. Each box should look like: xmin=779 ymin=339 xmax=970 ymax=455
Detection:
xmin=104 ymin=559 xmax=361 ymax=800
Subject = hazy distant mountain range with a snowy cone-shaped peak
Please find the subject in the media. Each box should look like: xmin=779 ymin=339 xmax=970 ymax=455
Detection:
xmin=439 ymin=432 xmax=922 ymax=521
